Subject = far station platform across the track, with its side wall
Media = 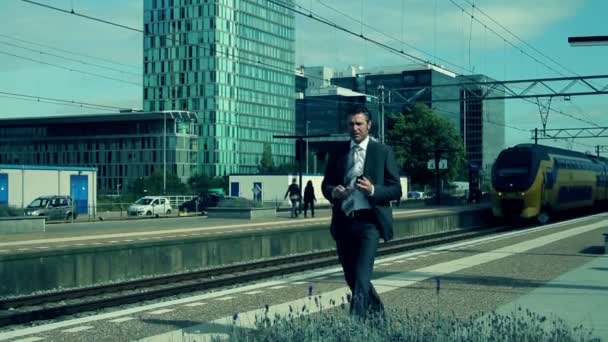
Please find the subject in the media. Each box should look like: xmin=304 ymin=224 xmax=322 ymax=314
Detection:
xmin=0 ymin=205 xmax=491 ymax=297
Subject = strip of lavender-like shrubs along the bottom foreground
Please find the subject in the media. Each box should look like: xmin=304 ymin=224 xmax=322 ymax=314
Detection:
xmin=221 ymin=305 xmax=599 ymax=342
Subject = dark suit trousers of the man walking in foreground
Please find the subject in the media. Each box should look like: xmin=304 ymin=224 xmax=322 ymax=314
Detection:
xmin=336 ymin=218 xmax=384 ymax=317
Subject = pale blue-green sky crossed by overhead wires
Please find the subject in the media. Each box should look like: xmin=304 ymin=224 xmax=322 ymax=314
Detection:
xmin=0 ymin=0 xmax=608 ymax=154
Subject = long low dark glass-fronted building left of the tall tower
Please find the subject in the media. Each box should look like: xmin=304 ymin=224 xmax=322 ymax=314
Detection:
xmin=0 ymin=111 xmax=200 ymax=193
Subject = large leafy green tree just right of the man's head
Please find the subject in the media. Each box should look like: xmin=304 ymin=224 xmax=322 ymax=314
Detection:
xmin=387 ymin=104 xmax=465 ymax=185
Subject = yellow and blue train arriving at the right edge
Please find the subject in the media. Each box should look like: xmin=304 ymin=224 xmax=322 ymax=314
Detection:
xmin=490 ymin=144 xmax=608 ymax=223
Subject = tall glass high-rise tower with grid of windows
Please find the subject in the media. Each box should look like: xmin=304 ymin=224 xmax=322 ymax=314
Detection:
xmin=143 ymin=0 xmax=295 ymax=176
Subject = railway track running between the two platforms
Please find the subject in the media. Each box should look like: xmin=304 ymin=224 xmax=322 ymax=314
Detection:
xmin=0 ymin=223 xmax=509 ymax=327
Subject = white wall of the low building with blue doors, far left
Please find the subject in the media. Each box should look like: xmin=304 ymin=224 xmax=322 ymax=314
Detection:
xmin=0 ymin=165 xmax=97 ymax=214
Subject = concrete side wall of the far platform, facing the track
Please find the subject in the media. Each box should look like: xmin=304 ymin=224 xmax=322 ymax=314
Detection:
xmin=0 ymin=209 xmax=492 ymax=297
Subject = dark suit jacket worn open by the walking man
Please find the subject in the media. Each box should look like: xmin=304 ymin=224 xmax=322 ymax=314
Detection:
xmin=322 ymin=140 xmax=401 ymax=241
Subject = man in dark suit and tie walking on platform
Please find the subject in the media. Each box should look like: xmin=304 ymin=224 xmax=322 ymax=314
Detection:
xmin=322 ymin=106 xmax=401 ymax=317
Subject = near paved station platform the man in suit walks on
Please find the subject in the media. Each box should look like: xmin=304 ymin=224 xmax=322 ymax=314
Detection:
xmin=0 ymin=214 xmax=608 ymax=342
